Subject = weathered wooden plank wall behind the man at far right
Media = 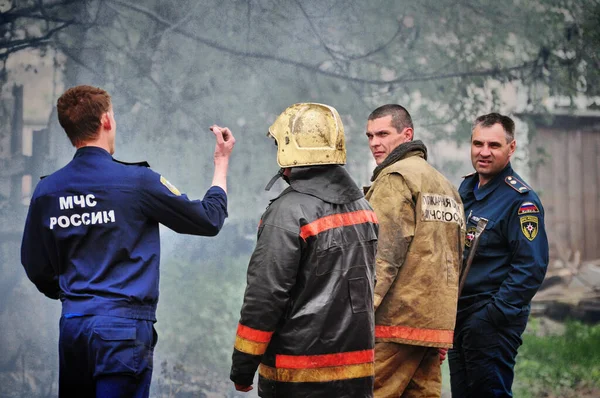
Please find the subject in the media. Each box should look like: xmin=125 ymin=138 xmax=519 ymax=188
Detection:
xmin=530 ymin=112 xmax=600 ymax=260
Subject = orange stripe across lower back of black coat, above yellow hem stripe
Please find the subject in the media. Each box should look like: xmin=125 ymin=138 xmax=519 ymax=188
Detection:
xmin=275 ymin=350 xmax=375 ymax=369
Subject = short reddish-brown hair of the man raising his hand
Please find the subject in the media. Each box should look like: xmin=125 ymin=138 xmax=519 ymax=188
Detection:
xmin=56 ymin=85 xmax=111 ymax=146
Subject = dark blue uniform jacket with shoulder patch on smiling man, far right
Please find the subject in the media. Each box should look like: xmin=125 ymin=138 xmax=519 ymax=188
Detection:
xmin=458 ymin=163 xmax=549 ymax=321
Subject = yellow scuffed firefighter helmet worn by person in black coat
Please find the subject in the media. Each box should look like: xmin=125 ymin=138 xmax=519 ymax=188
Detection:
xmin=268 ymin=102 xmax=346 ymax=168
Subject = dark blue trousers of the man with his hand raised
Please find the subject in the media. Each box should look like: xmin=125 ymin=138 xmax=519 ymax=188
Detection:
xmin=58 ymin=315 xmax=157 ymax=398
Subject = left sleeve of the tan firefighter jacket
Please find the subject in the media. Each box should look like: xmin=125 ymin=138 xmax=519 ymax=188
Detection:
xmin=369 ymin=174 xmax=416 ymax=309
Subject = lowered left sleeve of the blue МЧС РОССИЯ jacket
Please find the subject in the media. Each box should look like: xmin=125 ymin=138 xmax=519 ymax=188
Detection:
xmin=21 ymin=200 xmax=60 ymax=299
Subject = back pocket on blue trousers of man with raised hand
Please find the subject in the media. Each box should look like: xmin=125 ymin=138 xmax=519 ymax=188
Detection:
xmin=92 ymin=325 xmax=138 ymax=377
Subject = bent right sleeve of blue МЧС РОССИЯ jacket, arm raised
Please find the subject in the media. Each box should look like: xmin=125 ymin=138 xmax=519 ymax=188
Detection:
xmin=140 ymin=169 xmax=227 ymax=236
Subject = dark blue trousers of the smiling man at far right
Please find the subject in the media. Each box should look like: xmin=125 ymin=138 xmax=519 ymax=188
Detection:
xmin=448 ymin=303 xmax=529 ymax=398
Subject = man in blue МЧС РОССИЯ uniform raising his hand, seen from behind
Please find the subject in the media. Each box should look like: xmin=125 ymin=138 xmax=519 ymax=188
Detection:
xmin=21 ymin=86 xmax=235 ymax=397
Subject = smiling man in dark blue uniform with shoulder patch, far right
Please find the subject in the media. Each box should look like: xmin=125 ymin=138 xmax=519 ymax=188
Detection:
xmin=448 ymin=113 xmax=548 ymax=398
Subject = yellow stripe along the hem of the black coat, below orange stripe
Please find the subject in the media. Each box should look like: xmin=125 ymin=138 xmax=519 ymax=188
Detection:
xmin=258 ymin=363 xmax=375 ymax=383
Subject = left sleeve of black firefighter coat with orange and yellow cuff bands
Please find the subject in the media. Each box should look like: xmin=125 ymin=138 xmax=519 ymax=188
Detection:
xmin=230 ymin=216 xmax=303 ymax=385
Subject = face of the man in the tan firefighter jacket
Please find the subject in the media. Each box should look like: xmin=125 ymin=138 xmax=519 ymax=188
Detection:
xmin=366 ymin=115 xmax=413 ymax=166
